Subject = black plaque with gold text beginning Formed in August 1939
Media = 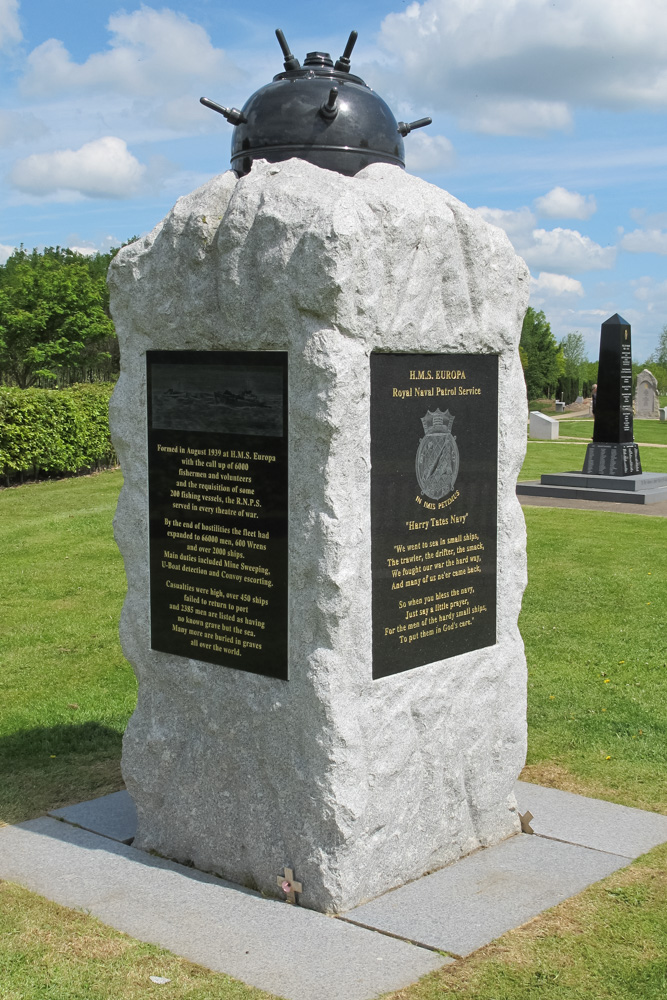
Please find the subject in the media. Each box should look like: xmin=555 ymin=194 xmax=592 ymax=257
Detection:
xmin=146 ymin=351 xmax=287 ymax=680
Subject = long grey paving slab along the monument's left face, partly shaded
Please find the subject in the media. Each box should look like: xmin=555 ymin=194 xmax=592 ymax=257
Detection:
xmin=0 ymin=817 xmax=452 ymax=1000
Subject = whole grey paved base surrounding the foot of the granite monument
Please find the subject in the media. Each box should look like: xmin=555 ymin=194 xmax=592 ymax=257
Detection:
xmin=0 ymin=782 xmax=667 ymax=1000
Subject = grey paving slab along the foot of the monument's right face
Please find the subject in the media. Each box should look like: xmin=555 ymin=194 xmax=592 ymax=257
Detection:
xmin=345 ymin=834 xmax=629 ymax=956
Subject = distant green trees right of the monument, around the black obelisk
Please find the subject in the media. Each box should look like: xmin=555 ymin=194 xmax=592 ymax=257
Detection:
xmin=519 ymin=306 xmax=667 ymax=403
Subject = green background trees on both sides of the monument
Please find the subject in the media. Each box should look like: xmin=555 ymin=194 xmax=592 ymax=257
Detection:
xmin=0 ymin=244 xmax=667 ymax=402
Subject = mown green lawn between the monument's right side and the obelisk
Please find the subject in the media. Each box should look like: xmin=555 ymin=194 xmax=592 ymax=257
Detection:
xmin=519 ymin=507 xmax=667 ymax=813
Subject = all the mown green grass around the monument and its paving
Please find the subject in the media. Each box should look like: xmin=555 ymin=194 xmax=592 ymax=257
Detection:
xmin=0 ymin=470 xmax=667 ymax=1000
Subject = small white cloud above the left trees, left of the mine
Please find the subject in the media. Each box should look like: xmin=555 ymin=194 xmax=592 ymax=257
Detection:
xmin=10 ymin=136 xmax=147 ymax=198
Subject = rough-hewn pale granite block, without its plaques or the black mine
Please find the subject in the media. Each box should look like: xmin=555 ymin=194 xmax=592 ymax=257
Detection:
xmin=110 ymin=160 xmax=528 ymax=912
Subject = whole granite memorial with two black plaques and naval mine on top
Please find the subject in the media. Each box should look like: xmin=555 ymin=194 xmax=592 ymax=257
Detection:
xmin=110 ymin=27 xmax=528 ymax=913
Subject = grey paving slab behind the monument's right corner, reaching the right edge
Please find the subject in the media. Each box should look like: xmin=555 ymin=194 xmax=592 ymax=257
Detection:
xmin=515 ymin=781 xmax=667 ymax=858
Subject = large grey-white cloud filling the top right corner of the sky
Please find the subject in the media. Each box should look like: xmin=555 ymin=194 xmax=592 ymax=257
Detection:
xmin=379 ymin=0 xmax=667 ymax=134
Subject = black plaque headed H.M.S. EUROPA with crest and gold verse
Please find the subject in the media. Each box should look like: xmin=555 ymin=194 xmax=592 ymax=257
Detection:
xmin=371 ymin=353 xmax=498 ymax=678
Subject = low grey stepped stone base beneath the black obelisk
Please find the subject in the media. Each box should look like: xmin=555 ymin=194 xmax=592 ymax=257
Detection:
xmin=516 ymin=472 xmax=667 ymax=504
